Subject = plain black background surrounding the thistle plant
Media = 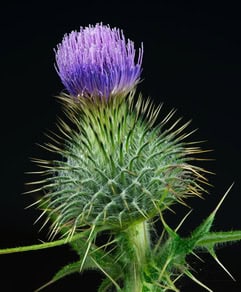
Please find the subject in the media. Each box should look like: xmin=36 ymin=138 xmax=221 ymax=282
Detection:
xmin=0 ymin=1 xmax=241 ymax=292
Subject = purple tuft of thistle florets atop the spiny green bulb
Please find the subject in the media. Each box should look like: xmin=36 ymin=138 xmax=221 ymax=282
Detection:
xmin=55 ymin=23 xmax=143 ymax=98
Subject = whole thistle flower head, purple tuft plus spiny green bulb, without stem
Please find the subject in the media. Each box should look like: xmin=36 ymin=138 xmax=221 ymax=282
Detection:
xmin=29 ymin=24 xmax=205 ymax=240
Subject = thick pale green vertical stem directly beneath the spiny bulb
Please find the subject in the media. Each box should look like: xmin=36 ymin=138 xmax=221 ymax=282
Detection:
xmin=124 ymin=222 xmax=150 ymax=292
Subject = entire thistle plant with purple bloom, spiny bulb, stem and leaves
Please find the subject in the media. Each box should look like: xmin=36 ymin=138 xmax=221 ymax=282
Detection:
xmin=0 ymin=24 xmax=241 ymax=292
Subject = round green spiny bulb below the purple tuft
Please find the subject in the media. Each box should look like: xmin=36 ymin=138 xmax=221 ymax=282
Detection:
xmin=30 ymin=92 xmax=205 ymax=235
